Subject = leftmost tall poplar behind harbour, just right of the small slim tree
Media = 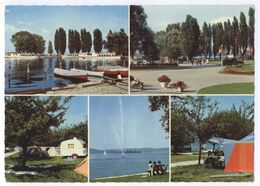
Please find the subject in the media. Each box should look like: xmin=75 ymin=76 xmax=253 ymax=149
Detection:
xmin=54 ymin=28 xmax=66 ymax=55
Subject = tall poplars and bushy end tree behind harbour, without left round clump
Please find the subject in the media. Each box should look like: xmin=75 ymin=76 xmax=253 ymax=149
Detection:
xmin=50 ymin=28 xmax=128 ymax=55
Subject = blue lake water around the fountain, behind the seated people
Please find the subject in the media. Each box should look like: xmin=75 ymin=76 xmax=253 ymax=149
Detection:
xmin=90 ymin=149 xmax=169 ymax=179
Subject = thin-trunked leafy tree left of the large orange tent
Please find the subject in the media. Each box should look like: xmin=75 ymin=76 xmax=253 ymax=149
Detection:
xmin=172 ymin=96 xmax=217 ymax=164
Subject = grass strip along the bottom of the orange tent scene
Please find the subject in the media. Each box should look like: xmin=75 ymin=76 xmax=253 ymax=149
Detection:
xmin=171 ymin=165 xmax=254 ymax=182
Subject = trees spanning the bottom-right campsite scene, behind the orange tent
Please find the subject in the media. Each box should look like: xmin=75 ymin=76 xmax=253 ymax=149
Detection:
xmin=171 ymin=96 xmax=254 ymax=164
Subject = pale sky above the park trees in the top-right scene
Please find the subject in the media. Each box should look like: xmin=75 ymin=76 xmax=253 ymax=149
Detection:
xmin=143 ymin=5 xmax=253 ymax=32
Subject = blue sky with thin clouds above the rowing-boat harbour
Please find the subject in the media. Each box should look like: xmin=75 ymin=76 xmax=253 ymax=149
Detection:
xmin=5 ymin=6 xmax=128 ymax=52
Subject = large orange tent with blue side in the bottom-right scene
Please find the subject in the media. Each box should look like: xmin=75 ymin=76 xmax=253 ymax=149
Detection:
xmin=223 ymin=133 xmax=254 ymax=172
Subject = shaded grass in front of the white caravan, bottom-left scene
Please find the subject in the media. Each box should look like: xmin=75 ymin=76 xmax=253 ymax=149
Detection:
xmin=5 ymin=155 xmax=88 ymax=182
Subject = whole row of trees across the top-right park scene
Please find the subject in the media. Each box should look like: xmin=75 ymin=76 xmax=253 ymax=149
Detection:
xmin=130 ymin=6 xmax=255 ymax=60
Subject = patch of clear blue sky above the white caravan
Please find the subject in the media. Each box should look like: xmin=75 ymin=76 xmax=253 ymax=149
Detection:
xmin=60 ymin=96 xmax=88 ymax=127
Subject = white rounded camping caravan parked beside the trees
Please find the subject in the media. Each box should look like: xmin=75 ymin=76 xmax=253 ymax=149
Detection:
xmin=60 ymin=138 xmax=87 ymax=157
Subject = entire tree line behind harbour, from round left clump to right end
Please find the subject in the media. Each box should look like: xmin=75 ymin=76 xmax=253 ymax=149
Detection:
xmin=11 ymin=27 xmax=128 ymax=56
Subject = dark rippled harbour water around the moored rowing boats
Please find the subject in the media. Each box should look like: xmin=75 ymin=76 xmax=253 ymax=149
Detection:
xmin=5 ymin=58 xmax=127 ymax=94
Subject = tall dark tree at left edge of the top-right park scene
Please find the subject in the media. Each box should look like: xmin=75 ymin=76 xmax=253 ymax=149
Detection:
xmin=130 ymin=5 xmax=160 ymax=60
